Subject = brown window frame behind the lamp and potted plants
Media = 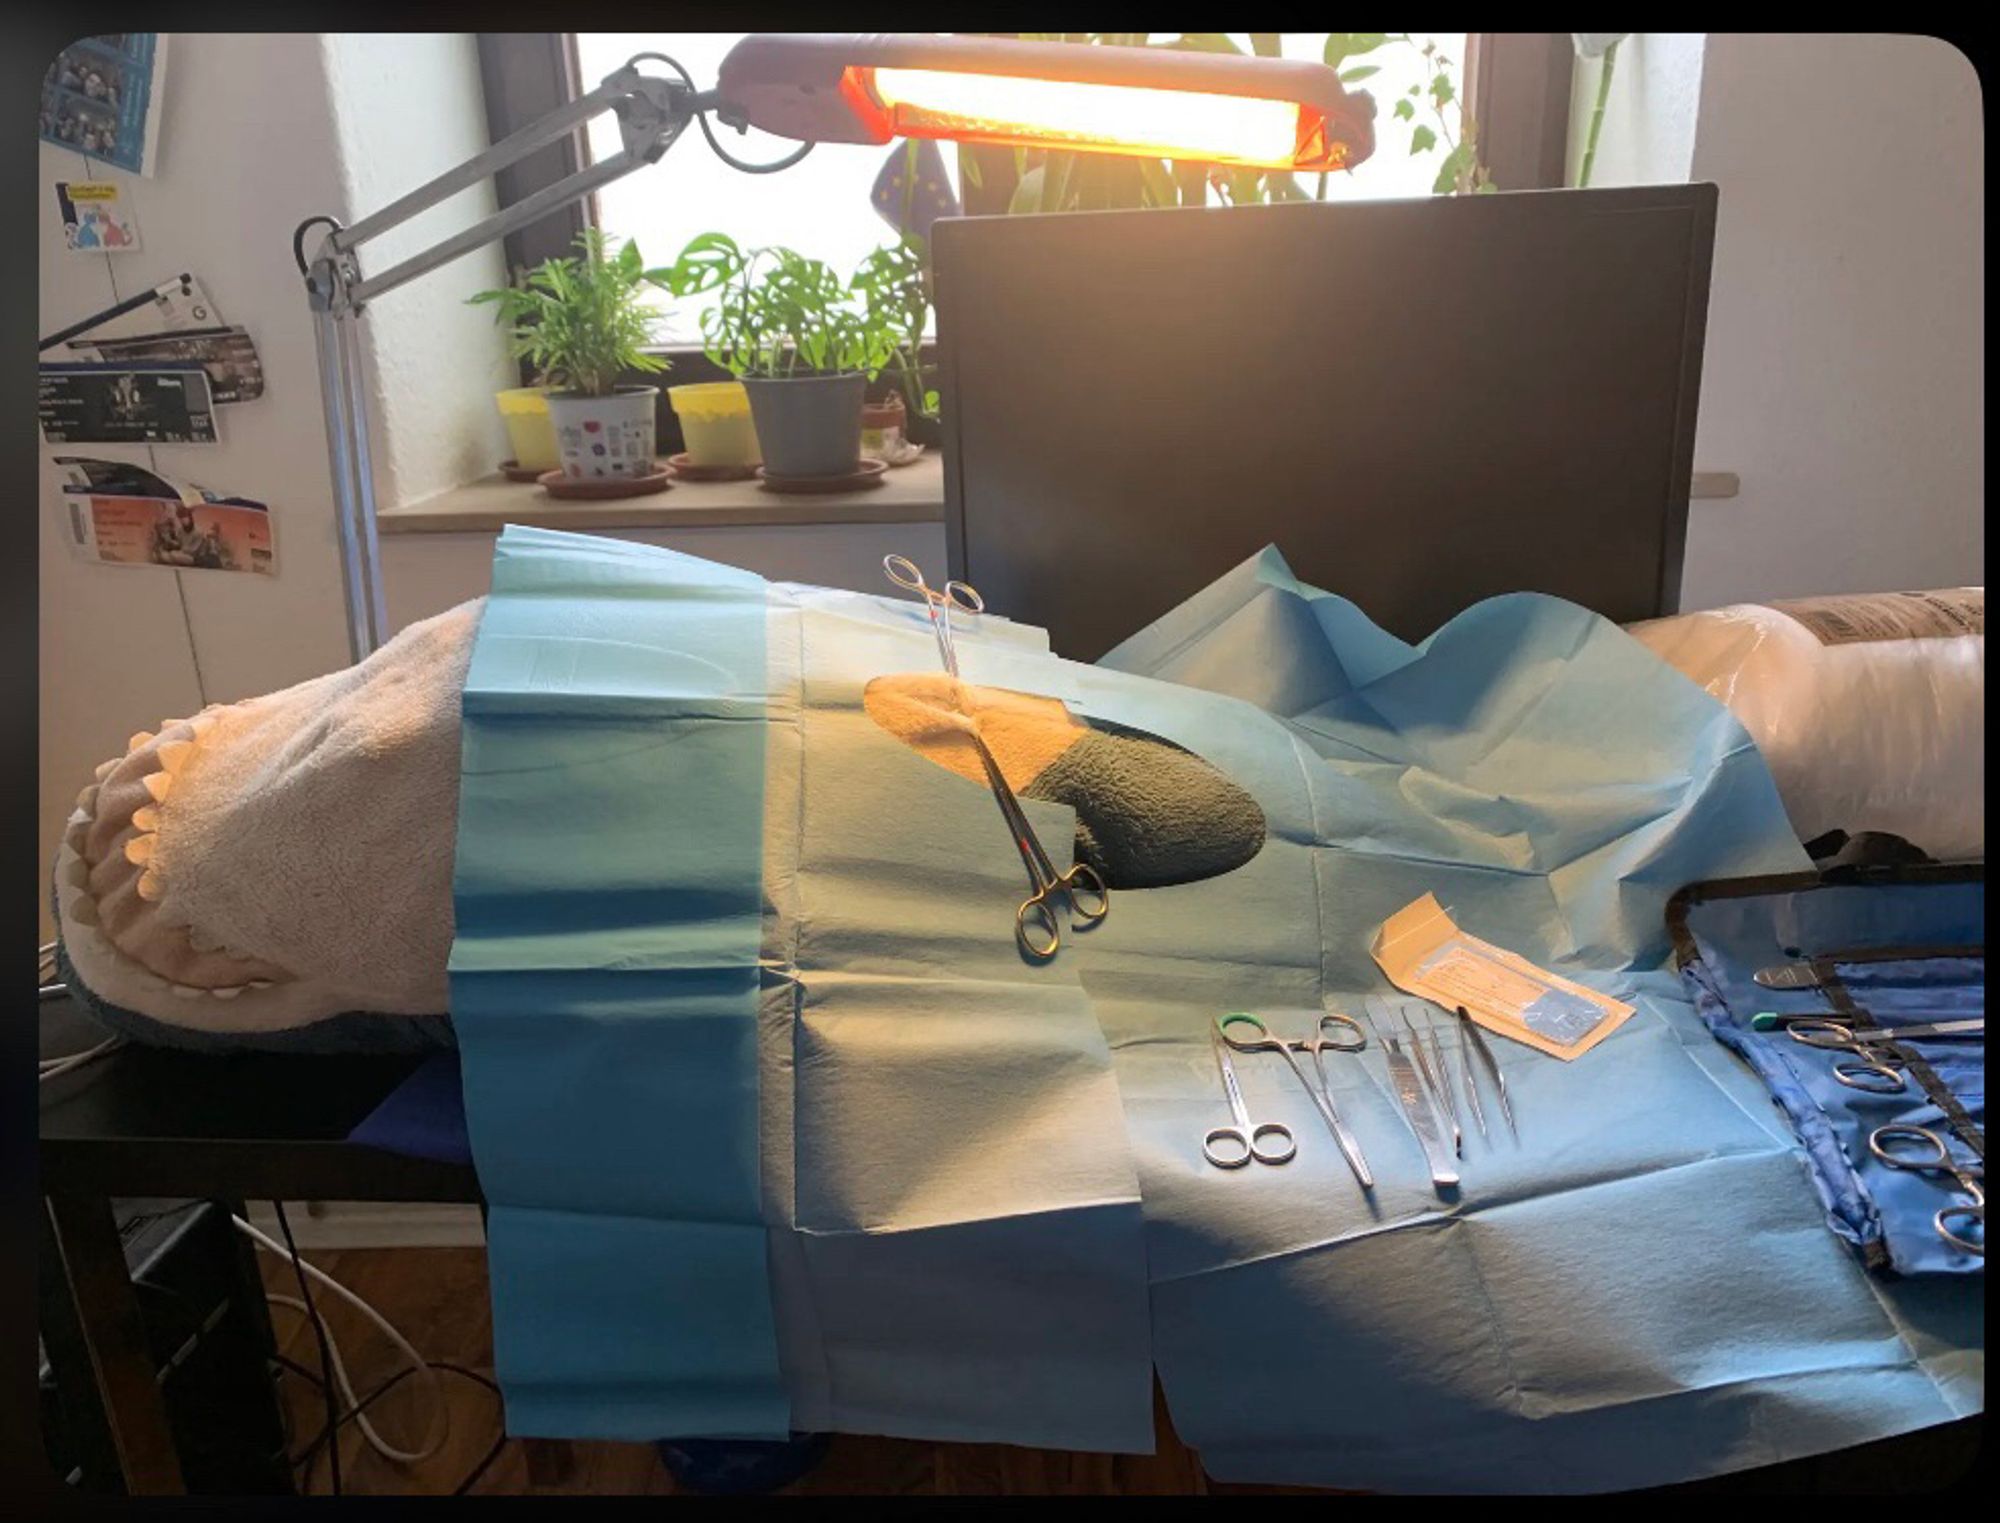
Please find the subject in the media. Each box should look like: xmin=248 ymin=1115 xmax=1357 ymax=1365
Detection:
xmin=478 ymin=32 xmax=1576 ymax=454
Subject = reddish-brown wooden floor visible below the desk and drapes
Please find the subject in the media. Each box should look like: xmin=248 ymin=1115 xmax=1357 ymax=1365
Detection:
xmin=260 ymin=1247 xmax=1328 ymax=1497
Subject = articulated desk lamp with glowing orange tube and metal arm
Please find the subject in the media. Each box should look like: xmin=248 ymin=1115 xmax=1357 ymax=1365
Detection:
xmin=292 ymin=34 xmax=1374 ymax=662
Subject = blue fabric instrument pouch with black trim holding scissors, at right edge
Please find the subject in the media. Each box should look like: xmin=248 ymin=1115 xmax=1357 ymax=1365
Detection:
xmin=1668 ymin=865 xmax=1986 ymax=1275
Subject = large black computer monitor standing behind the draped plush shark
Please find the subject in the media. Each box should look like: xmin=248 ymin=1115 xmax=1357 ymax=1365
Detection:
xmin=934 ymin=186 xmax=1716 ymax=660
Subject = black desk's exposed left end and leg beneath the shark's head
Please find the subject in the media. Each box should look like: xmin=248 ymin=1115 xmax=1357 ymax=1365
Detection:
xmin=40 ymin=1001 xmax=480 ymax=1495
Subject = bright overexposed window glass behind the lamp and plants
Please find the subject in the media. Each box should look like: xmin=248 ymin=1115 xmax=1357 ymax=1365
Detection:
xmin=576 ymin=32 xmax=1466 ymax=344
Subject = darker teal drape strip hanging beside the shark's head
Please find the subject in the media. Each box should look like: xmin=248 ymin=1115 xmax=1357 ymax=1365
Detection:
xmin=450 ymin=528 xmax=790 ymax=1439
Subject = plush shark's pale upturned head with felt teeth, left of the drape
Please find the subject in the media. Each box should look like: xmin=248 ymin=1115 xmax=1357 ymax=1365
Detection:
xmin=56 ymin=600 xmax=482 ymax=1031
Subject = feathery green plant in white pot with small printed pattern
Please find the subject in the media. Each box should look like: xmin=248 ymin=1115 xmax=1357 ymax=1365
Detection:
xmin=472 ymin=228 xmax=668 ymax=478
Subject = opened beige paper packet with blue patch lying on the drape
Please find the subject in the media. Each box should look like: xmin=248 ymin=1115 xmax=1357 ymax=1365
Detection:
xmin=1370 ymin=893 xmax=1632 ymax=1059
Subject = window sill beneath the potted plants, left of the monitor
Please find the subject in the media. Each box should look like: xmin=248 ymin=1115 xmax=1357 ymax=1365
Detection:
xmin=376 ymin=450 xmax=944 ymax=534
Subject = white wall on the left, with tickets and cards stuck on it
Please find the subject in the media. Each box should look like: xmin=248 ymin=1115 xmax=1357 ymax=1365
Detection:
xmin=36 ymin=32 xmax=506 ymax=939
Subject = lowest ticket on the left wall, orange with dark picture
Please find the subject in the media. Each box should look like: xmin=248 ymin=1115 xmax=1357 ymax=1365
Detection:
xmin=56 ymin=456 xmax=278 ymax=576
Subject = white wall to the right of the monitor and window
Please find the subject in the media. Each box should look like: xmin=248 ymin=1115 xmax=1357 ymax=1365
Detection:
xmin=1570 ymin=32 xmax=1986 ymax=608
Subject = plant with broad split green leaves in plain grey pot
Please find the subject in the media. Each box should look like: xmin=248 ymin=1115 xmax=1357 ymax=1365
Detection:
xmin=666 ymin=232 xmax=894 ymax=478
